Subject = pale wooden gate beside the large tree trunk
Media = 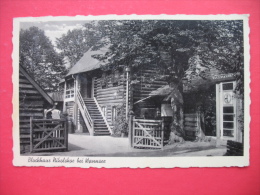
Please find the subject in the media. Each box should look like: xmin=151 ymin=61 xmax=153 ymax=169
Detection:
xmin=132 ymin=118 xmax=163 ymax=149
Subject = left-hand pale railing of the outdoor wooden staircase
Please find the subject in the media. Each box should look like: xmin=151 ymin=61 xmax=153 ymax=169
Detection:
xmin=76 ymin=91 xmax=94 ymax=135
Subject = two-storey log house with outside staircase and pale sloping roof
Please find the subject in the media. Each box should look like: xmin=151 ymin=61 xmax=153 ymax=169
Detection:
xmin=64 ymin=47 xmax=167 ymax=136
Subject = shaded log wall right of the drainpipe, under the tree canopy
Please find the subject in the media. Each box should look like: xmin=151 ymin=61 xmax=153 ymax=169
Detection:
xmin=133 ymin=67 xmax=167 ymax=117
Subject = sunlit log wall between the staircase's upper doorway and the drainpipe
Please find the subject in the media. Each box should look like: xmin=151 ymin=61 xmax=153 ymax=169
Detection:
xmin=94 ymin=73 xmax=126 ymax=129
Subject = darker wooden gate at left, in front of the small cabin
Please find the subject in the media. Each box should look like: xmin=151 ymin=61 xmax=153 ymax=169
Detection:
xmin=30 ymin=117 xmax=68 ymax=152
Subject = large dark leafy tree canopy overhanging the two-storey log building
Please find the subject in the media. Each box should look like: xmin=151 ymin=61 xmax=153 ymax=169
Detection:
xmin=90 ymin=20 xmax=244 ymax=93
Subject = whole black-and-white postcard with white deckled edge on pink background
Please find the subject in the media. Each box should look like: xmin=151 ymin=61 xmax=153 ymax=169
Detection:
xmin=12 ymin=15 xmax=250 ymax=168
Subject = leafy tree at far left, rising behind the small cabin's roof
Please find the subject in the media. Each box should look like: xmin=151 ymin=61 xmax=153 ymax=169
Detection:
xmin=19 ymin=27 xmax=66 ymax=92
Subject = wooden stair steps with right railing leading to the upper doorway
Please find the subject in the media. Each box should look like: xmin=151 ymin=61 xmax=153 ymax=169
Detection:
xmin=84 ymin=98 xmax=111 ymax=136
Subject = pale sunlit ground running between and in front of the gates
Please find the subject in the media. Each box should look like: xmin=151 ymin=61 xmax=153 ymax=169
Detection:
xmin=27 ymin=134 xmax=226 ymax=157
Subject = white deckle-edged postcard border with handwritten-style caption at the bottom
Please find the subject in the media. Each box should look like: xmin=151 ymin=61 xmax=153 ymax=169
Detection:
xmin=12 ymin=14 xmax=251 ymax=168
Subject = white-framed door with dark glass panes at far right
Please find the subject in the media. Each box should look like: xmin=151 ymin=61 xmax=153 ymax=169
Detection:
xmin=217 ymin=81 xmax=237 ymax=140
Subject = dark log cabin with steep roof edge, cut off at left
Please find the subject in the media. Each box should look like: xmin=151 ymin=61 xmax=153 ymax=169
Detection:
xmin=19 ymin=66 xmax=54 ymax=153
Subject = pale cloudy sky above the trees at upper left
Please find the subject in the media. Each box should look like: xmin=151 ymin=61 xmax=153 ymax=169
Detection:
xmin=20 ymin=20 xmax=88 ymax=45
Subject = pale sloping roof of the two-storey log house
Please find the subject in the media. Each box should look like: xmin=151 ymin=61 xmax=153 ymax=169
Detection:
xmin=67 ymin=46 xmax=108 ymax=76
